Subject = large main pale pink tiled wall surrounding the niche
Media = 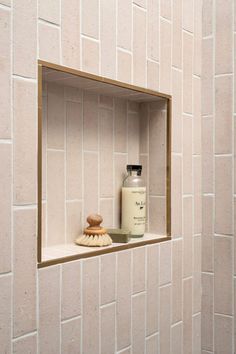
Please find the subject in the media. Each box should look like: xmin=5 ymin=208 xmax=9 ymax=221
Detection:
xmin=0 ymin=0 xmax=202 ymax=354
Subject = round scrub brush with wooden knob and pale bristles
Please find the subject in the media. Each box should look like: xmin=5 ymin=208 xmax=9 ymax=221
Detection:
xmin=75 ymin=214 xmax=112 ymax=247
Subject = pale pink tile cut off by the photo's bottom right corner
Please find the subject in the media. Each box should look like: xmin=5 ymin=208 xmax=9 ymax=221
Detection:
xmin=214 ymin=315 xmax=233 ymax=354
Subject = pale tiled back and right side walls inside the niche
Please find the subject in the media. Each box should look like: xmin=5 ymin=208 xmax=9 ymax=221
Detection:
xmin=42 ymin=83 xmax=167 ymax=247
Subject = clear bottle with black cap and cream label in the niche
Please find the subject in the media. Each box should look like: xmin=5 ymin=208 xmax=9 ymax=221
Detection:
xmin=121 ymin=165 xmax=146 ymax=237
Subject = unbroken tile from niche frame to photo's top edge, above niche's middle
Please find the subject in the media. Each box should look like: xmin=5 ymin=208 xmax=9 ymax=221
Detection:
xmin=100 ymin=0 xmax=116 ymax=78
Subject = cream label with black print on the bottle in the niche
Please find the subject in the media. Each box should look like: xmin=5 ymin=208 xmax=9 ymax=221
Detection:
xmin=122 ymin=187 xmax=146 ymax=236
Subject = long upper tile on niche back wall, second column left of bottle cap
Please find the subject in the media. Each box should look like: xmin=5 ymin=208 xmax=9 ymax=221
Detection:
xmin=99 ymin=108 xmax=114 ymax=197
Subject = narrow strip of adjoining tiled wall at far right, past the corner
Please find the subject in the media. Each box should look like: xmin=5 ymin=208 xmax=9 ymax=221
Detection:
xmin=202 ymin=0 xmax=236 ymax=354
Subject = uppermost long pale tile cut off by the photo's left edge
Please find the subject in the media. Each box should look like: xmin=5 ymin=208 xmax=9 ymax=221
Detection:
xmin=0 ymin=9 xmax=11 ymax=139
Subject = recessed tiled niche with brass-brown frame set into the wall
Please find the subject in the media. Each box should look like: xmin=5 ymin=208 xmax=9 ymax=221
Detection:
xmin=38 ymin=61 xmax=171 ymax=267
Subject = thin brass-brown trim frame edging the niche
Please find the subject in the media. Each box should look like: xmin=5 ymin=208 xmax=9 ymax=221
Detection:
xmin=37 ymin=60 xmax=172 ymax=268
